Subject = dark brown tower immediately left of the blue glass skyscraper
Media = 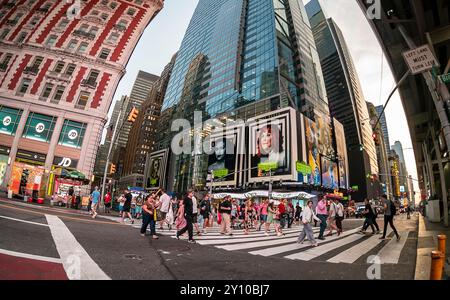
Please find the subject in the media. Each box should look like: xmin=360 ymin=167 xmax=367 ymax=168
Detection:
xmin=119 ymin=54 xmax=176 ymax=188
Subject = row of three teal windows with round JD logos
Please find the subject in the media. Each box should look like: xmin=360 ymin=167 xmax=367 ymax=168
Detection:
xmin=0 ymin=105 xmax=87 ymax=149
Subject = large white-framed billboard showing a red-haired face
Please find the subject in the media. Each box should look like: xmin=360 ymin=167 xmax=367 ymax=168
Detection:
xmin=249 ymin=108 xmax=297 ymax=182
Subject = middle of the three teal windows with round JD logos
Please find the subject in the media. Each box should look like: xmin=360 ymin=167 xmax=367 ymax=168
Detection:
xmin=23 ymin=112 xmax=57 ymax=143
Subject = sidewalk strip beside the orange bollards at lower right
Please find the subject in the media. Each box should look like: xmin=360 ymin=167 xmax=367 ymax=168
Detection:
xmin=414 ymin=215 xmax=450 ymax=280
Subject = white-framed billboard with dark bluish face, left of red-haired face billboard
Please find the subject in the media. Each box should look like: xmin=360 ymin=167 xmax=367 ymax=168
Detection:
xmin=206 ymin=126 xmax=244 ymax=186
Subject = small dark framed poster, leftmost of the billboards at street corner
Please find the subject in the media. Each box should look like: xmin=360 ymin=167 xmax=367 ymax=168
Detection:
xmin=146 ymin=149 xmax=169 ymax=190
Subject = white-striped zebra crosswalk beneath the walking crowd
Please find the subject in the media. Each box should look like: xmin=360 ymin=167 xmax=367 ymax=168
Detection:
xmin=102 ymin=214 xmax=410 ymax=264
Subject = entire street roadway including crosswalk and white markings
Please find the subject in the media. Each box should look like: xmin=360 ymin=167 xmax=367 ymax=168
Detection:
xmin=0 ymin=200 xmax=418 ymax=280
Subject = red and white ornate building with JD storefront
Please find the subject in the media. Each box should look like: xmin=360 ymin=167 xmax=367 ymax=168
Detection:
xmin=0 ymin=0 xmax=164 ymax=197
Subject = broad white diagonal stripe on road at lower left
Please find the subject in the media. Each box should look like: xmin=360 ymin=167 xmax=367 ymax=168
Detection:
xmin=45 ymin=215 xmax=111 ymax=280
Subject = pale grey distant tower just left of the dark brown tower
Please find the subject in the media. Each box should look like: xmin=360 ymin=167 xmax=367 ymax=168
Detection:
xmin=117 ymin=71 xmax=159 ymax=148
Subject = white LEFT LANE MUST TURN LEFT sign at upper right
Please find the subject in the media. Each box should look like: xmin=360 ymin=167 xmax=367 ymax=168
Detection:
xmin=403 ymin=45 xmax=439 ymax=75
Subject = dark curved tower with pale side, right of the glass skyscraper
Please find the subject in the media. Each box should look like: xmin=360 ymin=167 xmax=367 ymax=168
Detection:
xmin=306 ymin=0 xmax=379 ymax=199
